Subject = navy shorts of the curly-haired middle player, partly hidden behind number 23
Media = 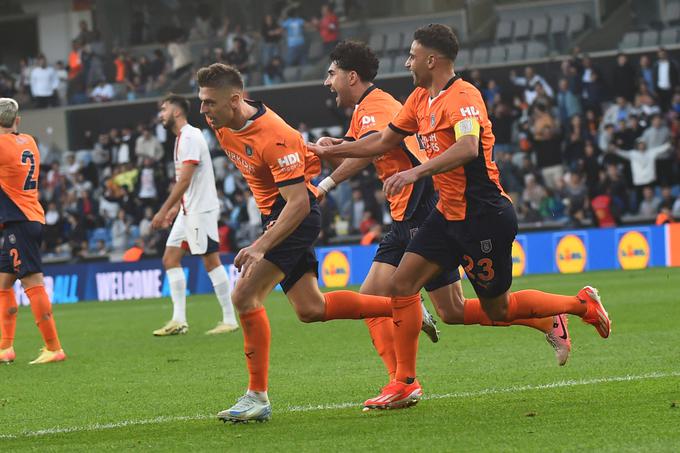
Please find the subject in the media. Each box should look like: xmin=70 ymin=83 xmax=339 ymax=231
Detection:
xmin=373 ymin=219 xmax=460 ymax=291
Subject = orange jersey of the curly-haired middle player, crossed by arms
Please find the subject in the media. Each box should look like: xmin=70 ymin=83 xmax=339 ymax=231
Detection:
xmin=345 ymin=85 xmax=432 ymax=221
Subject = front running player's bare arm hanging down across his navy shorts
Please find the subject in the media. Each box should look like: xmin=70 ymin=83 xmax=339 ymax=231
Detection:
xmin=234 ymin=182 xmax=310 ymax=278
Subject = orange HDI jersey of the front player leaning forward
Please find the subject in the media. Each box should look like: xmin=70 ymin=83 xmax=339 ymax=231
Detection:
xmin=215 ymin=101 xmax=321 ymax=216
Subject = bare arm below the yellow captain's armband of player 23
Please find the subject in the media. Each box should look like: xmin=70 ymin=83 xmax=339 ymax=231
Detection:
xmin=383 ymin=135 xmax=479 ymax=196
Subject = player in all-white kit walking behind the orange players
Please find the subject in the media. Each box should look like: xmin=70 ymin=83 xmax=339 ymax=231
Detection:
xmin=151 ymin=94 xmax=238 ymax=336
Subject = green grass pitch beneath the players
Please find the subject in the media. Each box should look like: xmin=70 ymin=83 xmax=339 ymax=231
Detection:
xmin=0 ymin=268 xmax=680 ymax=452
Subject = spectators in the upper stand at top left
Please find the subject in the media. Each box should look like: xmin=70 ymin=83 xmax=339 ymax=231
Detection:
xmin=0 ymin=3 xmax=340 ymax=108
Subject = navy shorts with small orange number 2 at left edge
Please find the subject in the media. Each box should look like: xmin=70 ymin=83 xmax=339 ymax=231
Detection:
xmin=0 ymin=222 xmax=43 ymax=279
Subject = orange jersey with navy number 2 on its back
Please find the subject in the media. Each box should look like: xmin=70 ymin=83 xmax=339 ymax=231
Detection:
xmin=0 ymin=133 xmax=45 ymax=224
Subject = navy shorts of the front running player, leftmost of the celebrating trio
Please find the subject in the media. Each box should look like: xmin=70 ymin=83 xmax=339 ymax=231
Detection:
xmin=262 ymin=203 xmax=321 ymax=293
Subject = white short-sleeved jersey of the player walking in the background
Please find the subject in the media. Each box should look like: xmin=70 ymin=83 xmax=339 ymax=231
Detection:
xmin=173 ymin=124 xmax=220 ymax=215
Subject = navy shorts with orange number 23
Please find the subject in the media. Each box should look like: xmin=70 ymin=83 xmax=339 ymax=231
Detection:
xmin=406 ymin=201 xmax=517 ymax=297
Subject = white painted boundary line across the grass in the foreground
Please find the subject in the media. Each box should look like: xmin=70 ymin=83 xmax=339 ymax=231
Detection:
xmin=0 ymin=371 xmax=680 ymax=439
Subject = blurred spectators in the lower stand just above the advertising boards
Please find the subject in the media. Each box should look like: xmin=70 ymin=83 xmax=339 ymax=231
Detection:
xmin=33 ymin=42 xmax=680 ymax=259
